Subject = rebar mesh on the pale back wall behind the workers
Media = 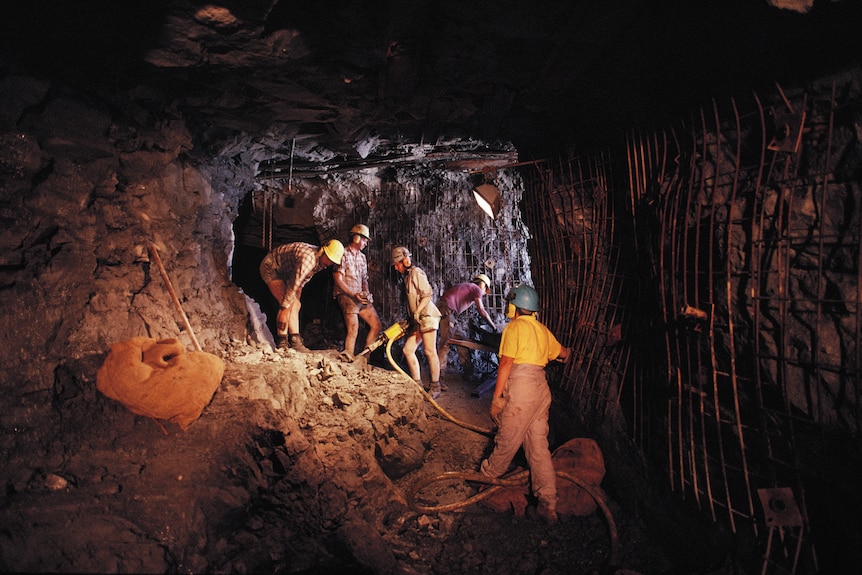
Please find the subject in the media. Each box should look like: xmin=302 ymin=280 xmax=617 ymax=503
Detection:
xmin=318 ymin=167 xmax=532 ymax=361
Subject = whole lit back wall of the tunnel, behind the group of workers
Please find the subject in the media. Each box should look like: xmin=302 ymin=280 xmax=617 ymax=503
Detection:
xmin=233 ymin=162 xmax=532 ymax=362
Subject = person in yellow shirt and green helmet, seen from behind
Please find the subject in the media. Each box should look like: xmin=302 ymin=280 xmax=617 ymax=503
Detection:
xmin=480 ymin=284 xmax=570 ymax=523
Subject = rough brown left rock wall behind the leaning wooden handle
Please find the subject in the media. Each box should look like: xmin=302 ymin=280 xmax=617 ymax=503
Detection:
xmin=0 ymin=75 xmax=248 ymax=400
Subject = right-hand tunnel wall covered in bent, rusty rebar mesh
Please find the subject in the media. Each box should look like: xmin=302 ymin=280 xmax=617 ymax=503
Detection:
xmin=524 ymin=66 xmax=862 ymax=572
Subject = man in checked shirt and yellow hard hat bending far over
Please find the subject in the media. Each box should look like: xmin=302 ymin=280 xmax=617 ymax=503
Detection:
xmin=260 ymin=240 xmax=344 ymax=353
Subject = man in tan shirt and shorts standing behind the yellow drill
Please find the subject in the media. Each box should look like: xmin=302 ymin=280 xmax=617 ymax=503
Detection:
xmin=392 ymin=246 xmax=440 ymax=399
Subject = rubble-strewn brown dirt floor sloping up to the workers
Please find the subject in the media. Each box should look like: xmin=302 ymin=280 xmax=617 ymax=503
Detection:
xmin=0 ymin=344 xmax=748 ymax=575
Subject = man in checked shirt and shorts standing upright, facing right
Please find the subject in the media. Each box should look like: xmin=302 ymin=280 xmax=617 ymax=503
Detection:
xmin=332 ymin=224 xmax=383 ymax=359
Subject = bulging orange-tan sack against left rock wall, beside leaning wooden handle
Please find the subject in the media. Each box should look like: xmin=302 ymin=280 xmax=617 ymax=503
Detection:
xmin=96 ymin=337 xmax=225 ymax=430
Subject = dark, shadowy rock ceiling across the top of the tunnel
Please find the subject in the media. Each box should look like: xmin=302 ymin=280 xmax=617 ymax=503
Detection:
xmin=0 ymin=0 xmax=862 ymax=158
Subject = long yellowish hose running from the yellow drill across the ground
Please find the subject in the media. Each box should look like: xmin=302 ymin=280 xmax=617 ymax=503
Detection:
xmin=386 ymin=332 xmax=619 ymax=565
